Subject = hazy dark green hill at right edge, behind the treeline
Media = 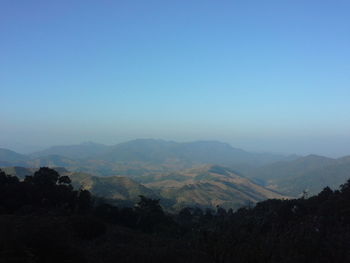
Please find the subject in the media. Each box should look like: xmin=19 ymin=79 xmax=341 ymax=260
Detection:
xmin=247 ymin=155 xmax=350 ymax=196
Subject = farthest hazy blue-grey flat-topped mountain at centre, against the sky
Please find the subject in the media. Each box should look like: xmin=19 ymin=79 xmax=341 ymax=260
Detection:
xmin=96 ymin=139 xmax=296 ymax=168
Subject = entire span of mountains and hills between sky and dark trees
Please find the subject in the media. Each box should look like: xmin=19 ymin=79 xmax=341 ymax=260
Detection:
xmin=0 ymin=139 xmax=350 ymax=209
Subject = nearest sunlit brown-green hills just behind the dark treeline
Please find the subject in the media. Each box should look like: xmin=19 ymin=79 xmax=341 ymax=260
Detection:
xmin=2 ymin=165 xmax=288 ymax=211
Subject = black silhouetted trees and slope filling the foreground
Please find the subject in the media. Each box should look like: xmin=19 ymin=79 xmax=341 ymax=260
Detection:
xmin=0 ymin=168 xmax=350 ymax=263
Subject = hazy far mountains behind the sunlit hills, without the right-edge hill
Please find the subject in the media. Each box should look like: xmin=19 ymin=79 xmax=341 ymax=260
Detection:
xmin=0 ymin=139 xmax=296 ymax=176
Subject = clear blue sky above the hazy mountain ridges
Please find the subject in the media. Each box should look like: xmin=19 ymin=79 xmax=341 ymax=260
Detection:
xmin=0 ymin=0 xmax=350 ymax=157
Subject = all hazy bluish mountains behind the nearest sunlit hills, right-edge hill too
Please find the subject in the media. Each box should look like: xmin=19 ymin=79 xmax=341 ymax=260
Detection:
xmin=0 ymin=139 xmax=350 ymax=201
